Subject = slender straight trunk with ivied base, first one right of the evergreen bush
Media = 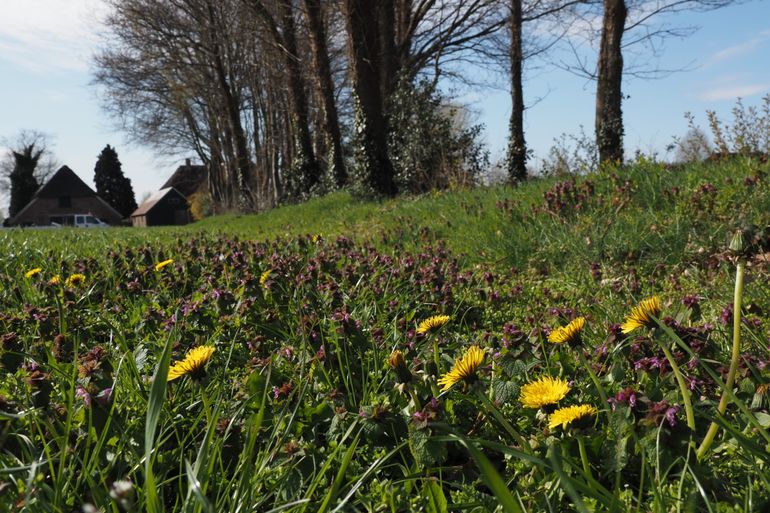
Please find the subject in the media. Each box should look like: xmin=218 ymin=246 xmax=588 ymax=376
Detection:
xmin=507 ymin=0 xmax=527 ymax=184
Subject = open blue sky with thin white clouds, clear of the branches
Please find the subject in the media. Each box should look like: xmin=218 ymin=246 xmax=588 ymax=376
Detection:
xmin=0 ymin=0 xmax=770 ymax=212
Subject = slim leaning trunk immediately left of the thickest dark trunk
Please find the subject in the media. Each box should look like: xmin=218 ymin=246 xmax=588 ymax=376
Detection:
xmin=305 ymin=0 xmax=348 ymax=187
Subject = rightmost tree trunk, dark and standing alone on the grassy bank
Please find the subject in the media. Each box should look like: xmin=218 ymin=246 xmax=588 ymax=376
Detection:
xmin=596 ymin=0 xmax=628 ymax=163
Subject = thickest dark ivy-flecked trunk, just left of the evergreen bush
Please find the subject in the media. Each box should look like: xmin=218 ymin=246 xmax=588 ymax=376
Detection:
xmin=345 ymin=0 xmax=397 ymax=196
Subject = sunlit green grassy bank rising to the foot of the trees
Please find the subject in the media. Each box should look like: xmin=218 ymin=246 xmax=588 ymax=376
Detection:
xmin=189 ymin=159 xmax=770 ymax=267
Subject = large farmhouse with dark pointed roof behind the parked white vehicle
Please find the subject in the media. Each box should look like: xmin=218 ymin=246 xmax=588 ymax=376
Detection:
xmin=8 ymin=166 xmax=122 ymax=226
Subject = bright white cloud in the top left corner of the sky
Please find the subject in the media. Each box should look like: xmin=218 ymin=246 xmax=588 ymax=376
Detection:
xmin=0 ymin=0 xmax=106 ymax=73
